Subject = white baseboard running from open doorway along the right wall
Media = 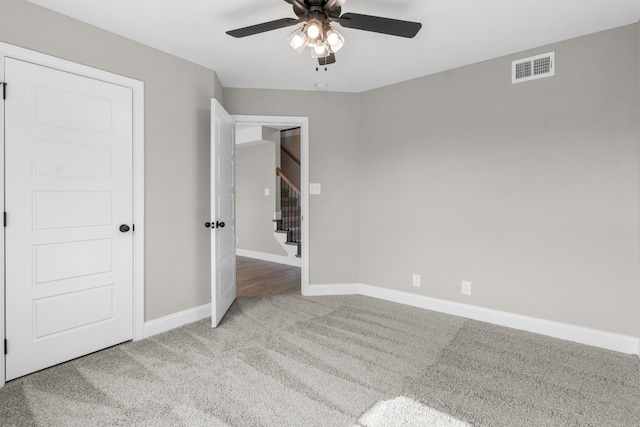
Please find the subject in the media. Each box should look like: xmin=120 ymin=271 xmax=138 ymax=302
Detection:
xmin=305 ymin=283 xmax=640 ymax=356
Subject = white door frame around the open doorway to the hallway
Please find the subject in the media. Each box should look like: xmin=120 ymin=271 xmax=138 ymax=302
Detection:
xmin=232 ymin=115 xmax=309 ymax=295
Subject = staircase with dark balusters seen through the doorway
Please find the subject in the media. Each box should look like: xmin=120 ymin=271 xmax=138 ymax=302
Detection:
xmin=273 ymin=168 xmax=302 ymax=258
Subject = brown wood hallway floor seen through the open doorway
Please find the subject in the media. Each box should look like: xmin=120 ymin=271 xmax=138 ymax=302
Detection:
xmin=236 ymin=256 xmax=302 ymax=298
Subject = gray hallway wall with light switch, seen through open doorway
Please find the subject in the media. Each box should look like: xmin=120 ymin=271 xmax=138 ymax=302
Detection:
xmin=236 ymin=142 xmax=287 ymax=256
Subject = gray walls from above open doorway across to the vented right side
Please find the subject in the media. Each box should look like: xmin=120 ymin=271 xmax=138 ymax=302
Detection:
xmin=225 ymin=25 xmax=640 ymax=336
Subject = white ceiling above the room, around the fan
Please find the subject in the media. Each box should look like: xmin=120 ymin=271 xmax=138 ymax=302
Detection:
xmin=29 ymin=0 xmax=640 ymax=92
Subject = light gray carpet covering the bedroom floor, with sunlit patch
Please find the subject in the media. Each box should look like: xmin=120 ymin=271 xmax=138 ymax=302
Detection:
xmin=0 ymin=296 xmax=640 ymax=427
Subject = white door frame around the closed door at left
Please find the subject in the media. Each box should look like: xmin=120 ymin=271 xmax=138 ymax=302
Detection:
xmin=0 ymin=42 xmax=144 ymax=387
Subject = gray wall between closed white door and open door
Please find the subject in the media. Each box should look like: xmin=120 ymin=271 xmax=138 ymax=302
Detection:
xmin=0 ymin=0 xmax=222 ymax=320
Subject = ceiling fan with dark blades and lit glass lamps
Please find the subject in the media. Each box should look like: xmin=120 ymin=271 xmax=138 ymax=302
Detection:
xmin=227 ymin=0 xmax=422 ymax=65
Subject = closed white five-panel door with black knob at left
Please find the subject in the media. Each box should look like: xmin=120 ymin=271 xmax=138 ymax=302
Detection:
xmin=5 ymin=58 xmax=133 ymax=379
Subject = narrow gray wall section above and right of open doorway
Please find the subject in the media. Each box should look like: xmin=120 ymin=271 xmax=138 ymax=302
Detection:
xmin=224 ymin=88 xmax=360 ymax=284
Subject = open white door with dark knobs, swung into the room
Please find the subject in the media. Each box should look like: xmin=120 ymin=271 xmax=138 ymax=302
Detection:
xmin=211 ymin=99 xmax=236 ymax=328
